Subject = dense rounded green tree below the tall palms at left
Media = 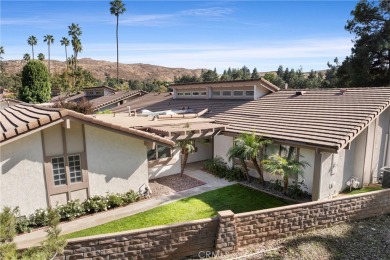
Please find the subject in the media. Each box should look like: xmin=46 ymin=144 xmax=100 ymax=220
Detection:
xmin=19 ymin=60 xmax=51 ymax=103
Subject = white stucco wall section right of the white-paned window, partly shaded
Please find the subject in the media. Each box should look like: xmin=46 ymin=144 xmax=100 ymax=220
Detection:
xmin=85 ymin=126 xmax=148 ymax=196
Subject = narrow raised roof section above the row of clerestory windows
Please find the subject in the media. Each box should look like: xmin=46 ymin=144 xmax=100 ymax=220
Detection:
xmin=169 ymin=78 xmax=280 ymax=92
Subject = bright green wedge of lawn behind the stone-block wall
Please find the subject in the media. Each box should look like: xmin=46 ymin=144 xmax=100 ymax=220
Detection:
xmin=65 ymin=184 xmax=291 ymax=239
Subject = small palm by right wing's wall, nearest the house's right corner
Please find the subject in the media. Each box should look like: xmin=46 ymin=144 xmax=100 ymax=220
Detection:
xmin=263 ymin=147 xmax=309 ymax=194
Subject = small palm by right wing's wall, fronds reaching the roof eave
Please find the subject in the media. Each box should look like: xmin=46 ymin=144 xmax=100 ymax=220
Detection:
xmin=229 ymin=133 xmax=271 ymax=184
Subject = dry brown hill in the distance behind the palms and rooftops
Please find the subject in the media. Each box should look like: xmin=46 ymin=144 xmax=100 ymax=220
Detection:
xmin=3 ymin=58 xmax=202 ymax=82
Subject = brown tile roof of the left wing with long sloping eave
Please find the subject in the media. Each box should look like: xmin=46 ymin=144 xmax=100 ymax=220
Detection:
xmin=0 ymin=104 xmax=175 ymax=146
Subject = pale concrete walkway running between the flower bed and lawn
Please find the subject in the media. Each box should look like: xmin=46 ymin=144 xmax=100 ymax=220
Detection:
xmin=14 ymin=166 xmax=235 ymax=248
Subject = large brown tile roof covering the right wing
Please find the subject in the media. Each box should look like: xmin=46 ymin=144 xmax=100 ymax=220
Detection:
xmin=111 ymin=88 xmax=390 ymax=151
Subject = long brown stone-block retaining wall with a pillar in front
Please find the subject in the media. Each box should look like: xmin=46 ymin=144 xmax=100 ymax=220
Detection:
xmin=57 ymin=189 xmax=390 ymax=259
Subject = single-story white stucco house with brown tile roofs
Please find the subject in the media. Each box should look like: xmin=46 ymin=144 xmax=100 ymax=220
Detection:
xmin=0 ymin=79 xmax=390 ymax=214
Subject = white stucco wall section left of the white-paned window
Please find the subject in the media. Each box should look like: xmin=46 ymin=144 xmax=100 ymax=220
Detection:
xmin=0 ymin=132 xmax=48 ymax=215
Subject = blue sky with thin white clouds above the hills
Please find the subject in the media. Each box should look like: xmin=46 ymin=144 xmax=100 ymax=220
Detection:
xmin=1 ymin=0 xmax=356 ymax=72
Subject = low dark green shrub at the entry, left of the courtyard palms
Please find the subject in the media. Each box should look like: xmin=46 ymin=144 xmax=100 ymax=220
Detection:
xmin=204 ymin=156 xmax=244 ymax=181
